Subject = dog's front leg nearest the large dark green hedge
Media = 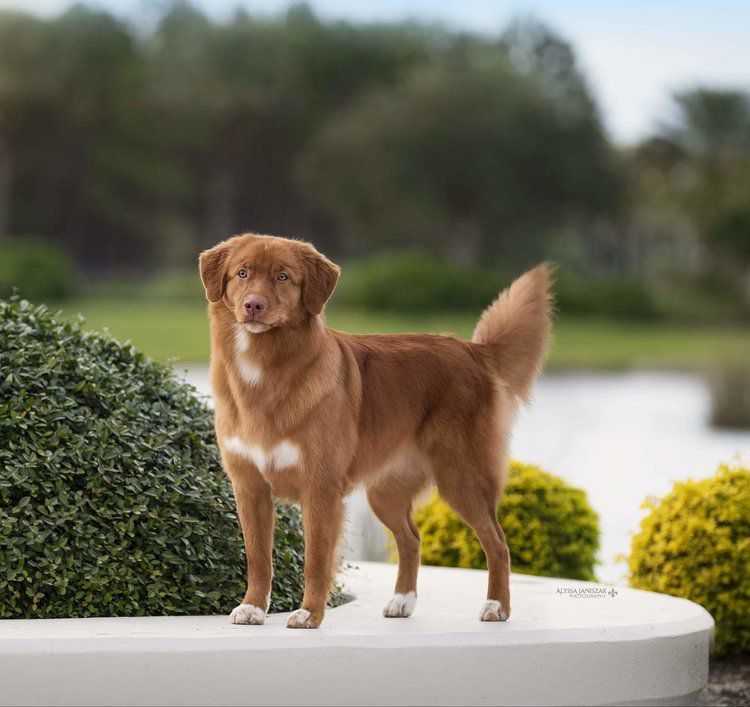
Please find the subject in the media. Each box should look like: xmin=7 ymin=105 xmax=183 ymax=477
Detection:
xmin=230 ymin=469 xmax=274 ymax=624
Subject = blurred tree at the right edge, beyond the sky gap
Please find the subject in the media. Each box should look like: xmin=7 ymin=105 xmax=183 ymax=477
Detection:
xmin=631 ymin=88 xmax=750 ymax=302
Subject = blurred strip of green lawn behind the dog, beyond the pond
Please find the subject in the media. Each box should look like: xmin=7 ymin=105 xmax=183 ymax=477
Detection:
xmin=57 ymin=299 xmax=750 ymax=369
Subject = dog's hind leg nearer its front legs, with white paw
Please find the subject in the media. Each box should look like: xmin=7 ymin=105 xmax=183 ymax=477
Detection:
xmin=367 ymin=462 xmax=427 ymax=618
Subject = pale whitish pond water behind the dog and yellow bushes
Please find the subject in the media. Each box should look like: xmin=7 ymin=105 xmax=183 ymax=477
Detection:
xmin=179 ymin=367 xmax=750 ymax=584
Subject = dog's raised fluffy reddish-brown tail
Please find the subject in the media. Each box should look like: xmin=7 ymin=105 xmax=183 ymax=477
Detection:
xmin=472 ymin=264 xmax=554 ymax=402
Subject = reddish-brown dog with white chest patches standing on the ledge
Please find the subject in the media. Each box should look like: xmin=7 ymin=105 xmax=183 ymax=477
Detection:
xmin=200 ymin=234 xmax=551 ymax=628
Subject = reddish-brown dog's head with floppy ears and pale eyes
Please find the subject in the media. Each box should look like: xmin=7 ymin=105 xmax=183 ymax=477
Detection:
xmin=200 ymin=234 xmax=339 ymax=334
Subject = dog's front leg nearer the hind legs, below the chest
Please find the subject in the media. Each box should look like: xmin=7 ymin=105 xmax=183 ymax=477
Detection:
xmin=286 ymin=489 xmax=344 ymax=628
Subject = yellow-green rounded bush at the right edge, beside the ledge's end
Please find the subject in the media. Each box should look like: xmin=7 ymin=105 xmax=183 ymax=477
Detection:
xmin=628 ymin=464 xmax=750 ymax=655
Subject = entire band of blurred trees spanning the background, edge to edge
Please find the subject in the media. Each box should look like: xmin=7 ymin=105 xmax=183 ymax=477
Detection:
xmin=0 ymin=1 xmax=750 ymax=319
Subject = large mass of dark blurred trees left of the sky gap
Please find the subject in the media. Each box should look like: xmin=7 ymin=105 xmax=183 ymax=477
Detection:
xmin=0 ymin=3 xmax=617 ymax=269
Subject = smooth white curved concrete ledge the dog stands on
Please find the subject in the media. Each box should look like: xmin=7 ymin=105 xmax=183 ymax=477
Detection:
xmin=0 ymin=563 xmax=713 ymax=705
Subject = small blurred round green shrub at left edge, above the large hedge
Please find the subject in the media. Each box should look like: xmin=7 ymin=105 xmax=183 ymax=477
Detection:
xmin=0 ymin=236 xmax=76 ymax=301
